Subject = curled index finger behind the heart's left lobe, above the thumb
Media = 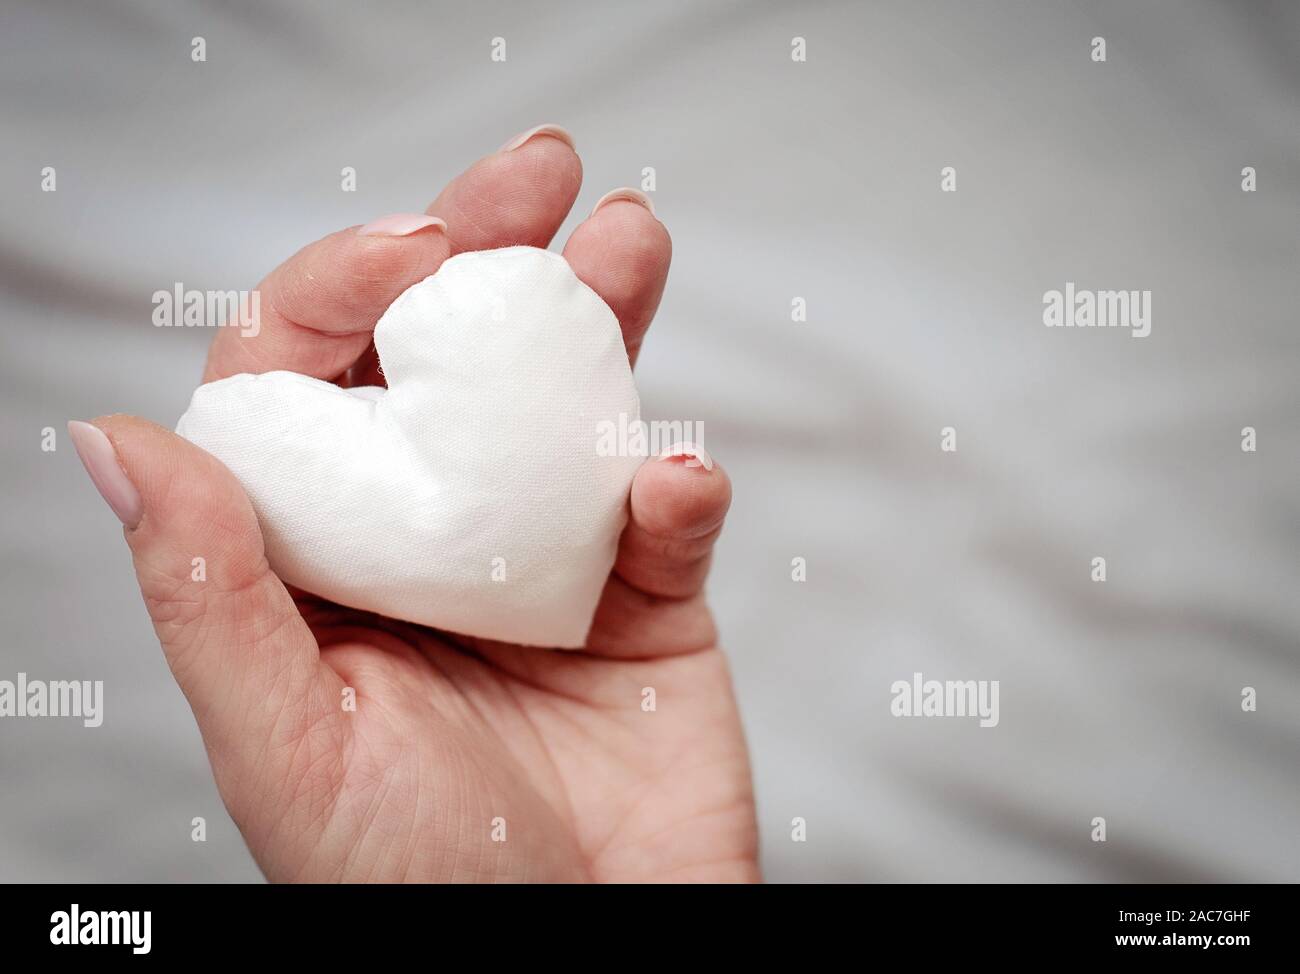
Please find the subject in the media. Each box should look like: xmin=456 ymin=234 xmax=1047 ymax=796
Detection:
xmin=203 ymin=213 xmax=451 ymax=382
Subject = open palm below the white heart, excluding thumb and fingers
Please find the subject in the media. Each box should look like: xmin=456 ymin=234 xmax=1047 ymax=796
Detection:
xmin=250 ymin=587 xmax=757 ymax=882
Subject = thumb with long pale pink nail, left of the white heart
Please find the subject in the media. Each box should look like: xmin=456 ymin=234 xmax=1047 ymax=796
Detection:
xmin=69 ymin=416 xmax=339 ymax=764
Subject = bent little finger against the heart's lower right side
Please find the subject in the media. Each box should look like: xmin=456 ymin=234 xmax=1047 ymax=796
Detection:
xmin=588 ymin=447 xmax=732 ymax=657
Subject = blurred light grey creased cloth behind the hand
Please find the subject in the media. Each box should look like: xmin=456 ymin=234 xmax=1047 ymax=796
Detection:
xmin=0 ymin=1 xmax=1300 ymax=880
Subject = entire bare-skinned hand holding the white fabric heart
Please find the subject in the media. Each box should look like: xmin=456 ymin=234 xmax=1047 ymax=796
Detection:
xmin=95 ymin=134 xmax=759 ymax=882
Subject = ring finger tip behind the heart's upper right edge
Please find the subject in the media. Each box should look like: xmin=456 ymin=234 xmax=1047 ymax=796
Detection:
xmin=564 ymin=189 xmax=672 ymax=364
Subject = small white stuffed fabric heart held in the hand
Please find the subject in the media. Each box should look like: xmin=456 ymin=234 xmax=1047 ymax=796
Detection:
xmin=177 ymin=247 xmax=642 ymax=648
